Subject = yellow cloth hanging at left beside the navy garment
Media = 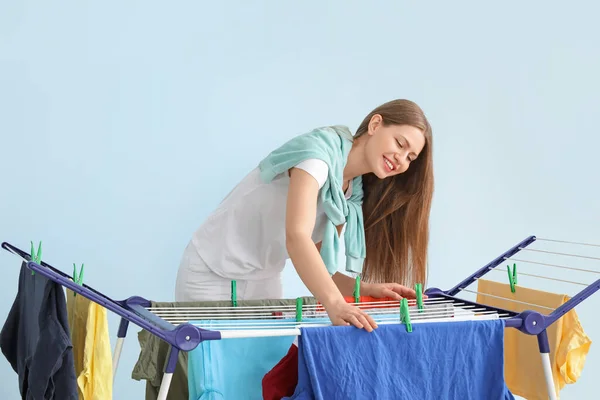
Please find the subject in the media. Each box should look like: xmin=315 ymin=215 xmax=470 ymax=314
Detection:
xmin=66 ymin=289 xmax=113 ymax=400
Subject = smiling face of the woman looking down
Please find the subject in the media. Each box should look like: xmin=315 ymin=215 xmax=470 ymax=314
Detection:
xmin=365 ymin=115 xmax=425 ymax=179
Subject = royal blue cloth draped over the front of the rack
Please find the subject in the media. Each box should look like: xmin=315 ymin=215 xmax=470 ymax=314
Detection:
xmin=286 ymin=319 xmax=514 ymax=400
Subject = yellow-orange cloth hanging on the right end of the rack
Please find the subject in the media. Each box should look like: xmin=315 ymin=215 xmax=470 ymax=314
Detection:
xmin=477 ymin=279 xmax=592 ymax=400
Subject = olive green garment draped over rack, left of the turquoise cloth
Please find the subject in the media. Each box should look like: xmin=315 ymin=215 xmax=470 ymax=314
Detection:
xmin=131 ymin=297 xmax=317 ymax=400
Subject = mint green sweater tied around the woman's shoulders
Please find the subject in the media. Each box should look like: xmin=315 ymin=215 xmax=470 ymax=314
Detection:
xmin=259 ymin=126 xmax=366 ymax=275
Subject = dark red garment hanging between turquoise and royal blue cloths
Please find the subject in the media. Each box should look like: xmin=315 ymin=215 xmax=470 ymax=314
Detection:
xmin=262 ymin=344 xmax=298 ymax=400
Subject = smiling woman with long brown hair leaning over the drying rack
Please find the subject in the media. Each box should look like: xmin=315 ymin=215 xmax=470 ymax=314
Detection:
xmin=176 ymin=100 xmax=433 ymax=331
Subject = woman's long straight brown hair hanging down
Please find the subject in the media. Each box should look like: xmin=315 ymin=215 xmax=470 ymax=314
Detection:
xmin=355 ymin=100 xmax=433 ymax=288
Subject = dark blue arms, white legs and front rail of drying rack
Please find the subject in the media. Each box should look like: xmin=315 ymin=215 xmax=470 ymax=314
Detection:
xmin=2 ymin=236 xmax=600 ymax=400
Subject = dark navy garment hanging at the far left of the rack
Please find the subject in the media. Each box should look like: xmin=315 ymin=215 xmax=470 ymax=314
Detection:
xmin=0 ymin=263 xmax=79 ymax=400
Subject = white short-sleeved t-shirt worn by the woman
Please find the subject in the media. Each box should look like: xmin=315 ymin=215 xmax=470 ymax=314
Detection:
xmin=185 ymin=159 xmax=352 ymax=280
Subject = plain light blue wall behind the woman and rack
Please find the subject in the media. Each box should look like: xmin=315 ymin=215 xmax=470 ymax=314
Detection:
xmin=0 ymin=1 xmax=600 ymax=399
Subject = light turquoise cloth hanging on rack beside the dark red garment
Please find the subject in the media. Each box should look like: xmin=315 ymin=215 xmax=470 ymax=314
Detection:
xmin=188 ymin=319 xmax=297 ymax=400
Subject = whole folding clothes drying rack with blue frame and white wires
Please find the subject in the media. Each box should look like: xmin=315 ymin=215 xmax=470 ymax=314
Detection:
xmin=2 ymin=236 xmax=600 ymax=400
